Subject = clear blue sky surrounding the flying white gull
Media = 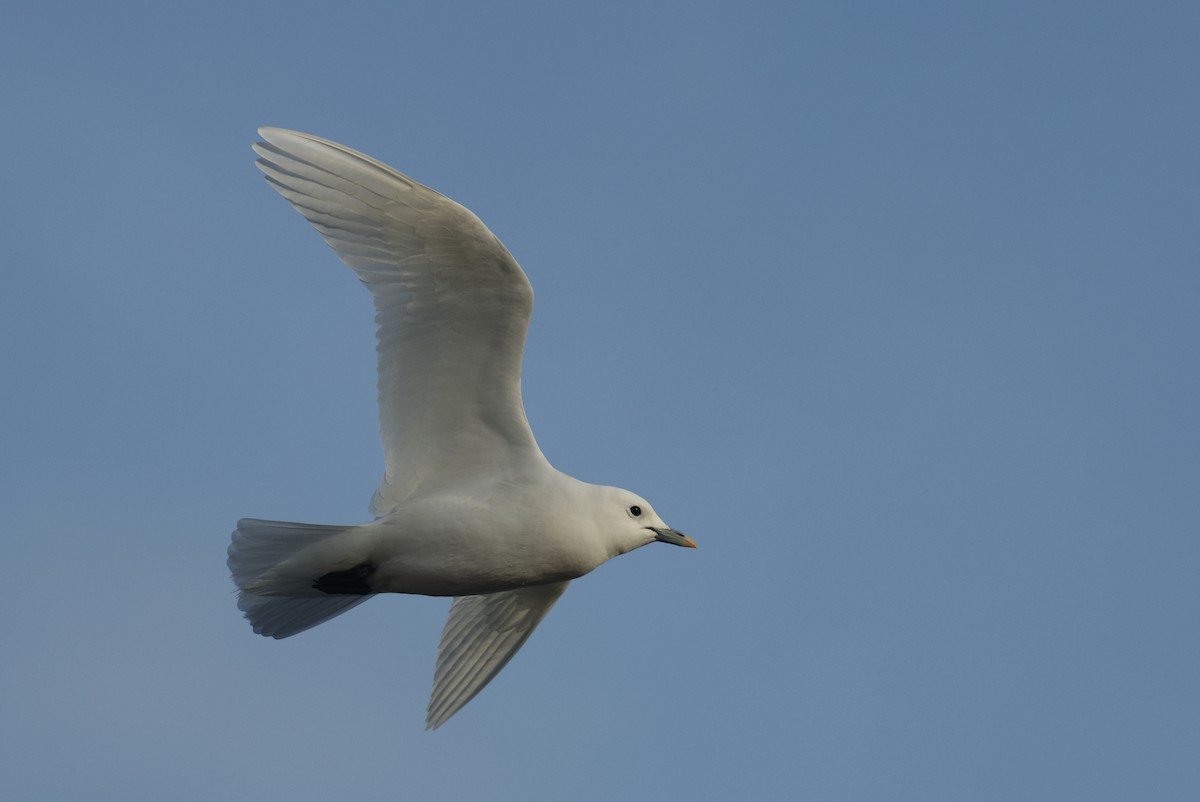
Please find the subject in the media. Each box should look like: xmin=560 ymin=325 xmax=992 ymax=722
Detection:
xmin=0 ymin=0 xmax=1200 ymax=802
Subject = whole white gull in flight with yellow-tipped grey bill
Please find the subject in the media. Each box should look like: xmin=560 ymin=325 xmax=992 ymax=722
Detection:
xmin=228 ymin=127 xmax=696 ymax=729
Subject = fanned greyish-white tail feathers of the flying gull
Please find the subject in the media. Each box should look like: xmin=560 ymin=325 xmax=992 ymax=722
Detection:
xmin=226 ymin=517 xmax=372 ymax=638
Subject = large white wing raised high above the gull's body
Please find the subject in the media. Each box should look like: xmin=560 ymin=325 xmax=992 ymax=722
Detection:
xmin=254 ymin=128 xmax=545 ymax=516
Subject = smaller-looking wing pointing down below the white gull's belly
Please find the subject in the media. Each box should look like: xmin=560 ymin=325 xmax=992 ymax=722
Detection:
xmin=425 ymin=582 xmax=569 ymax=730
